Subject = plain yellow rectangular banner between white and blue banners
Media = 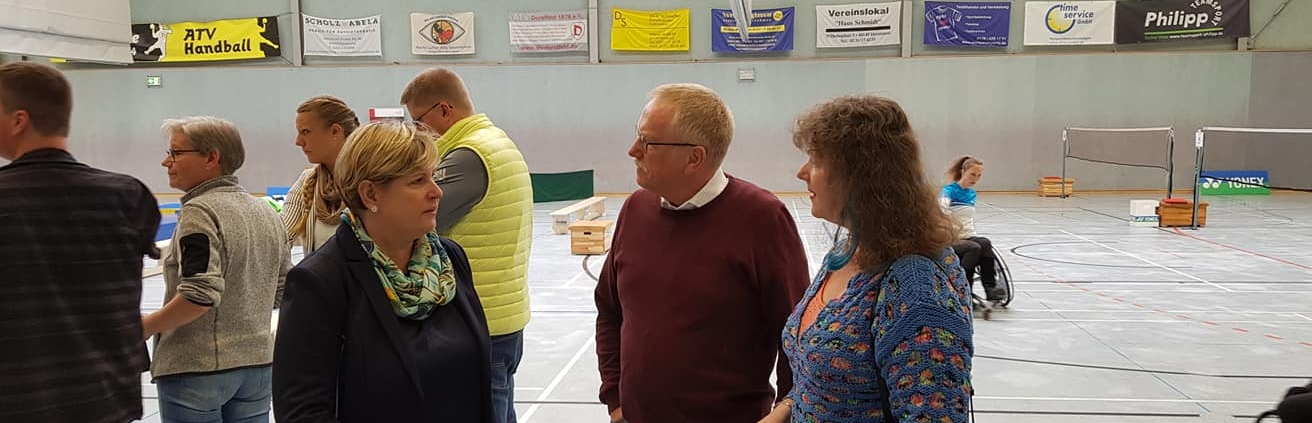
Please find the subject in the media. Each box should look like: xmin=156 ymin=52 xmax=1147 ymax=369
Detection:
xmin=610 ymin=8 xmax=691 ymax=51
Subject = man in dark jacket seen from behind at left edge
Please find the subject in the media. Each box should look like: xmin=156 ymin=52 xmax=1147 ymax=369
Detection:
xmin=0 ymin=62 xmax=160 ymax=423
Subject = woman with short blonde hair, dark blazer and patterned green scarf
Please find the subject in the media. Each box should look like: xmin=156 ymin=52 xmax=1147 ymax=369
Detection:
xmin=273 ymin=121 xmax=492 ymax=423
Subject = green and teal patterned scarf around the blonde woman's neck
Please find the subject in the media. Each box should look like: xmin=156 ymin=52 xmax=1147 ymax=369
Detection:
xmin=341 ymin=210 xmax=455 ymax=321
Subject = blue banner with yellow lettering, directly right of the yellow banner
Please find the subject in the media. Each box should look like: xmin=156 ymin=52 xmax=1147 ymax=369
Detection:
xmin=711 ymin=8 xmax=794 ymax=53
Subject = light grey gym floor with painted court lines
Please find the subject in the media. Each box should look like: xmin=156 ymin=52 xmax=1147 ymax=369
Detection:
xmin=135 ymin=192 xmax=1312 ymax=423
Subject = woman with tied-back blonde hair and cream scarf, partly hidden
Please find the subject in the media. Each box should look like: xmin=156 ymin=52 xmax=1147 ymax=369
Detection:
xmin=282 ymin=95 xmax=359 ymax=255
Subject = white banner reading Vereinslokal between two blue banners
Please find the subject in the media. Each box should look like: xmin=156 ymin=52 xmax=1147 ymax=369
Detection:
xmin=816 ymin=1 xmax=901 ymax=47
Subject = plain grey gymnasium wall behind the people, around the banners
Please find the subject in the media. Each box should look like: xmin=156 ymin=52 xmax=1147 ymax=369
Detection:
xmin=17 ymin=0 xmax=1312 ymax=192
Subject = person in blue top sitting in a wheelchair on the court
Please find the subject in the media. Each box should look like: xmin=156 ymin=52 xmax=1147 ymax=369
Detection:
xmin=939 ymin=156 xmax=1006 ymax=301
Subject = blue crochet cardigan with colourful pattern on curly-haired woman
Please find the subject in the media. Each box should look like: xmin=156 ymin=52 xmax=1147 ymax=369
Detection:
xmin=783 ymin=248 xmax=974 ymax=423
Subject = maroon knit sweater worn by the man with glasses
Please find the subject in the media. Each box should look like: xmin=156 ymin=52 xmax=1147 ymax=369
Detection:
xmin=596 ymin=176 xmax=810 ymax=423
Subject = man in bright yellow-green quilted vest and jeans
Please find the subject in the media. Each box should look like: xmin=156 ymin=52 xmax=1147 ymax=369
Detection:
xmin=401 ymin=67 xmax=533 ymax=423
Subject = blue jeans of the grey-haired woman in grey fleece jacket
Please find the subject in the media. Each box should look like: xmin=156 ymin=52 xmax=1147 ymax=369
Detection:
xmin=155 ymin=365 xmax=273 ymax=423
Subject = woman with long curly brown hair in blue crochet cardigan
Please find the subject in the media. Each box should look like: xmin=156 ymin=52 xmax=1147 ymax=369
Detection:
xmin=764 ymin=96 xmax=974 ymax=423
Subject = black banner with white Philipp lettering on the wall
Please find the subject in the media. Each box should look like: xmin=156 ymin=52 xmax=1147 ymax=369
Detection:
xmin=1117 ymin=0 xmax=1252 ymax=43
